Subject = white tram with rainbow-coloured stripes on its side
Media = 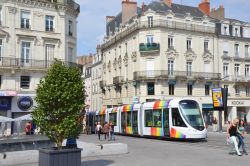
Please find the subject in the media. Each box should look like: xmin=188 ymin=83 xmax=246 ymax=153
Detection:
xmin=93 ymin=99 xmax=207 ymax=139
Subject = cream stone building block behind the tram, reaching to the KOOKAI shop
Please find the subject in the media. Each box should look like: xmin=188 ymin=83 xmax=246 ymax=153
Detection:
xmin=100 ymin=0 xmax=250 ymax=124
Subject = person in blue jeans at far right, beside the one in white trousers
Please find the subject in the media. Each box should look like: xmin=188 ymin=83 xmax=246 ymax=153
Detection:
xmin=238 ymin=119 xmax=248 ymax=155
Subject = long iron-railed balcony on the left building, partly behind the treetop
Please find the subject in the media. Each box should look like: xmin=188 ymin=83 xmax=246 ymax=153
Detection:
xmin=0 ymin=57 xmax=82 ymax=70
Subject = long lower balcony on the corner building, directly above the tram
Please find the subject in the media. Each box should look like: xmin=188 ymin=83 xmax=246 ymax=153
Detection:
xmin=134 ymin=70 xmax=221 ymax=80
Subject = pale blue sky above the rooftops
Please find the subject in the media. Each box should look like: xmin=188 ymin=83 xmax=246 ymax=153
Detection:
xmin=75 ymin=0 xmax=250 ymax=56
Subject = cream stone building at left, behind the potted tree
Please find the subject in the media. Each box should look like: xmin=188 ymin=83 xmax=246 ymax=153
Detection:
xmin=0 ymin=0 xmax=80 ymax=118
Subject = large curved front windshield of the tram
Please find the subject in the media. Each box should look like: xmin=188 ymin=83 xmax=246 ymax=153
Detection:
xmin=179 ymin=100 xmax=205 ymax=130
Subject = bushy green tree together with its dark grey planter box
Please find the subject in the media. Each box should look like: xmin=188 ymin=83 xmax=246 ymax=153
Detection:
xmin=32 ymin=60 xmax=85 ymax=166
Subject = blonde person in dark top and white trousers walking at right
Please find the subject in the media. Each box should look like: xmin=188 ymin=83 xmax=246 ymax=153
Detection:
xmin=227 ymin=119 xmax=242 ymax=156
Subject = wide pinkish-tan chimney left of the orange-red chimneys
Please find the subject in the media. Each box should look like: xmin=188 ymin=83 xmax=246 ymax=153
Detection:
xmin=122 ymin=0 xmax=137 ymax=24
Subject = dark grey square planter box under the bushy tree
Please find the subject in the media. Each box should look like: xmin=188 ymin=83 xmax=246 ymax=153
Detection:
xmin=39 ymin=148 xmax=82 ymax=166
